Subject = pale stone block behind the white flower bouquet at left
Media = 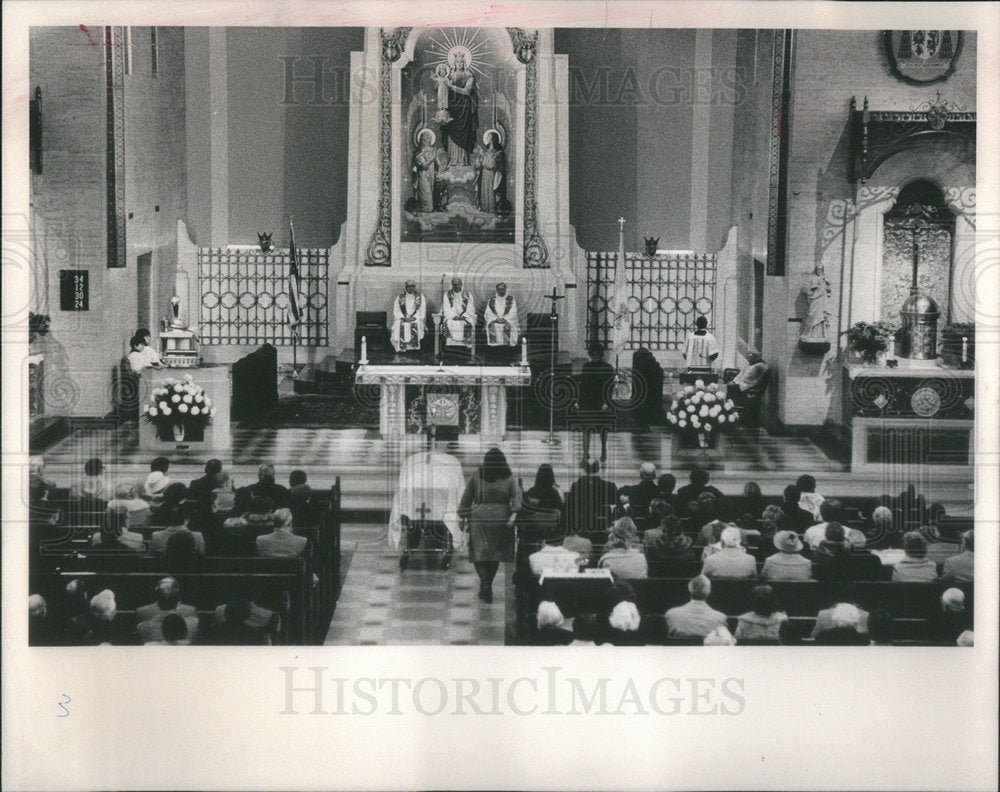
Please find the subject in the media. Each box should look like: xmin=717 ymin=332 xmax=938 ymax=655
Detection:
xmin=139 ymin=364 xmax=233 ymax=454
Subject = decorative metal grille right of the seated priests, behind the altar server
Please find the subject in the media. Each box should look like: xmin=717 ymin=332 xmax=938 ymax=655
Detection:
xmin=587 ymin=251 xmax=716 ymax=351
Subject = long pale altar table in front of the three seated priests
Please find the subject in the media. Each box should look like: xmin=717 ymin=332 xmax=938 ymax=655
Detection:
xmin=354 ymin=364 xmax=531 ymax=442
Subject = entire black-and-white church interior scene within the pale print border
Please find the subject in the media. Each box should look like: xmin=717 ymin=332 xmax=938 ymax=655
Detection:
xmin=21 ymin=25 xmax=977 ymax=646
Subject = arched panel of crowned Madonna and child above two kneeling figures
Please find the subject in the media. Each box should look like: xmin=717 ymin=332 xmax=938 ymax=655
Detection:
xmin=400 ymin=28 xmax=521 ymax=243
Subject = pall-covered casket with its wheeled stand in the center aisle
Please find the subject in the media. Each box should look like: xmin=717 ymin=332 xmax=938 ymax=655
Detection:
xmin=389 ymin=451 xmax=465 ymax=569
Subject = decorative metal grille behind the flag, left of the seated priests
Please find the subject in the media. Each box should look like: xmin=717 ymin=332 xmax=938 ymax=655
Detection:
xmin=198 ymin=248 xmax=329 ymax=346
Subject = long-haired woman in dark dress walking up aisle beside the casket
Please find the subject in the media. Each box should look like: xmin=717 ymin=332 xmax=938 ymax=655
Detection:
xmin=458 ymin=448 xmax=521 ymax=602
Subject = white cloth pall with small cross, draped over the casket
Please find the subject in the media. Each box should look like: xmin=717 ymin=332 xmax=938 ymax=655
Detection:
xmin=389 ymin=451 xmax=465 ymax=550
